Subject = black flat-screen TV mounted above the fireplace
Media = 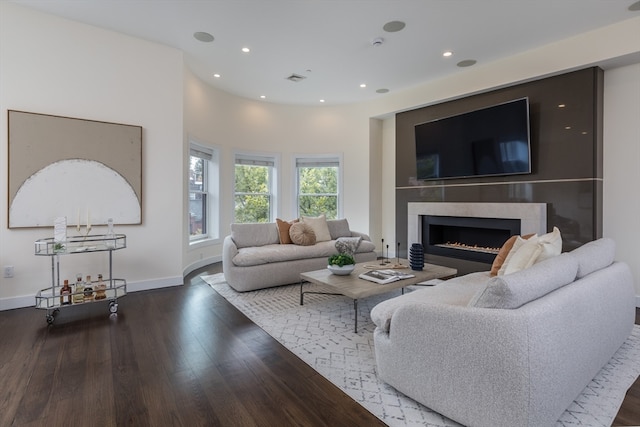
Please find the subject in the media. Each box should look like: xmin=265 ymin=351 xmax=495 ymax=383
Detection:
xmin=415 ymin=98 xmax=531 ymax=180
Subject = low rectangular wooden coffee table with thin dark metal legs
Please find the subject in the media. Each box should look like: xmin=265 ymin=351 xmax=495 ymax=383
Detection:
xmin=300 ymin=260 xmax=458 ymax=333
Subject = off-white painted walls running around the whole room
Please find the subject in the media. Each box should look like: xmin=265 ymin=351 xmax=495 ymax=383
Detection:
xmin=0 ymin=1 xmax=640 ymax=426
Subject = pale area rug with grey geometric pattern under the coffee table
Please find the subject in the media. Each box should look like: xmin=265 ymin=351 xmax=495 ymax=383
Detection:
xmin=202 ymin=274 xmax=640 ymax=427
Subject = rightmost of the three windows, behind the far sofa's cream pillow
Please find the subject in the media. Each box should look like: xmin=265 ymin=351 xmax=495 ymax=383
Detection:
xmin=296 ymin=156 xmax=342 ymax=219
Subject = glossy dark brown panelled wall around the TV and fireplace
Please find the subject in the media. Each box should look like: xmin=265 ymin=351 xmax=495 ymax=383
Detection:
xmin=396 ymin=67 xmax=603 ymax=271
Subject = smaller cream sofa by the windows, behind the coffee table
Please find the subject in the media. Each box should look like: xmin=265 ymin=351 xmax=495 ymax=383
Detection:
xmin=222 ymin=219 xmax=376 ymax=292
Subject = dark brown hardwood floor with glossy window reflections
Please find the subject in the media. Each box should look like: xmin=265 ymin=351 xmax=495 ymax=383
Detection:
xmin=0 ymin=264 xmax=640 ymax=427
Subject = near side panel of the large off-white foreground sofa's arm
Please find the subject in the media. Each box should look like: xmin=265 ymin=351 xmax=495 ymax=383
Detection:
xmin=374 ymin=302 xmax=532 ymax=426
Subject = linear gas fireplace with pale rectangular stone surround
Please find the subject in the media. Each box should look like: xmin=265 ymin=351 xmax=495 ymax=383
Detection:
xmin=407 ymin=202 xmax=547 ymax=264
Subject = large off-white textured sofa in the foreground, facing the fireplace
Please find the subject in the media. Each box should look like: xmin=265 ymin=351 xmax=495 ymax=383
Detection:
xmin=371 ymin=239 xmax=635 ymax=427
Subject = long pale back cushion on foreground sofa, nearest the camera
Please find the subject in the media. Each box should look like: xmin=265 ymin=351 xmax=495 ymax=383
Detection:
xmin=469 ymin=254 xmax=578 ymax=309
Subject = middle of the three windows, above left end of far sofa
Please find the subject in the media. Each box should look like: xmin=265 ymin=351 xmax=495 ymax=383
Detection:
xmin=234 ymin=154 xmax=276 ymax=223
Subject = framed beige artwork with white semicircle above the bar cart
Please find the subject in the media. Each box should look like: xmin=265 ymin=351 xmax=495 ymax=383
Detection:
xmin=7 ymin=110 xmax=143 ymax=228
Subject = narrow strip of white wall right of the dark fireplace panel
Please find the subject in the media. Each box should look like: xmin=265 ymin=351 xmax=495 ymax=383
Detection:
xmin=603 ymin=64 xmax=640 ymax=300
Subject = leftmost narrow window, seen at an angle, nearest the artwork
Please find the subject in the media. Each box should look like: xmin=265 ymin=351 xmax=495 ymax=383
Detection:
xmin=189 ymin=142 xmax=218 ymax=242
